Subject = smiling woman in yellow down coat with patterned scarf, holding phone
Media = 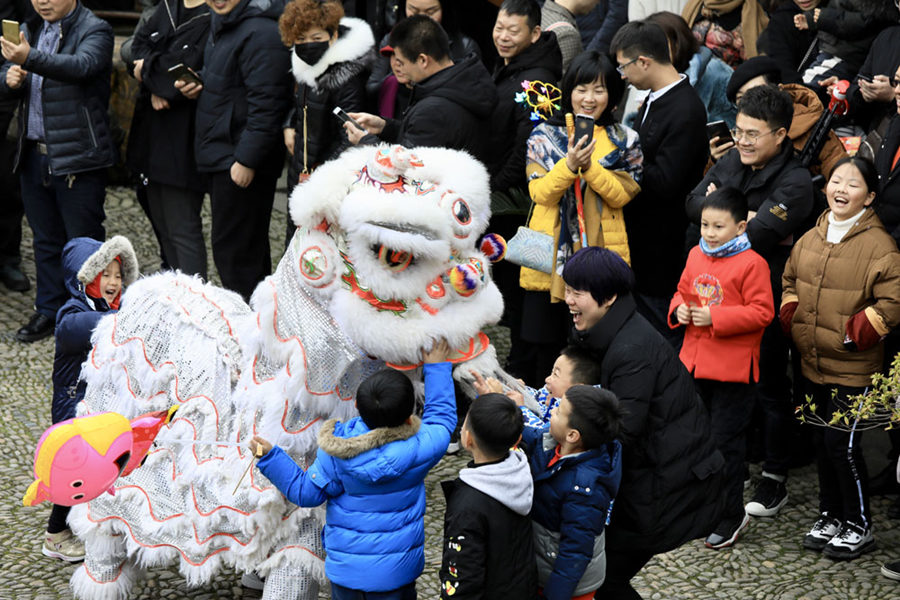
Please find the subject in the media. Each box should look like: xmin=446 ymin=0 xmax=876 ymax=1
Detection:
xmin=519 ymin=51 xmax=643 ymax=377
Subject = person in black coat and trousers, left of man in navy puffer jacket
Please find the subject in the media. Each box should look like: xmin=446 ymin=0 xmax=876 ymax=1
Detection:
xmin=127 ymin=0 xmax=210 ymax=279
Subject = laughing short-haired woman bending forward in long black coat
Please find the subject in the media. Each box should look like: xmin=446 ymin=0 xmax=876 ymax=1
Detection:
xmin=563 ymin=247 xmax=725 ymax=600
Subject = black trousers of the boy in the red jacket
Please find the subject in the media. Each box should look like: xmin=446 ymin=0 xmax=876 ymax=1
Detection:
xmin=694 ymin=379 xmax=756 ymax=519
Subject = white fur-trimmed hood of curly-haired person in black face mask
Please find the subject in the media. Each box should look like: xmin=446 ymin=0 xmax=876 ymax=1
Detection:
xmin=291 ymin=17 xmax=376 ymax=90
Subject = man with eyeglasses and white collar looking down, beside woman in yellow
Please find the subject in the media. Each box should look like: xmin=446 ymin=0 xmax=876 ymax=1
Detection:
xmin=610 ymin=21 xmax=707 ymax=348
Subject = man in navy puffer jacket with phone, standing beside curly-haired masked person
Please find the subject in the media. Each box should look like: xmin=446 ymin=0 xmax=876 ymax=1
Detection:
xmin=176 ymin=0 xmax=292 ymax=299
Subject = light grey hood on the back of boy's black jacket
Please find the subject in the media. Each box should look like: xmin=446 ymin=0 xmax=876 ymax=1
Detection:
xmin=459 ymin=451 xmax=534 ymax=515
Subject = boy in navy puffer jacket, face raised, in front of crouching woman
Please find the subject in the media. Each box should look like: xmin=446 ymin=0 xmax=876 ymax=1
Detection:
xmin=522 ymin=385 xmax=625 ymax=600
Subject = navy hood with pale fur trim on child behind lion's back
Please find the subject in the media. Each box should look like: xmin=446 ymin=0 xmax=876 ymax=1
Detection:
xmin=62 ymin=235 xmax=138 ymax=308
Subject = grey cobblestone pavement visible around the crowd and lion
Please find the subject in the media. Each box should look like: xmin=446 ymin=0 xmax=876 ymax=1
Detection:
xmin=0 ymin=188 xmax=900 ymax=600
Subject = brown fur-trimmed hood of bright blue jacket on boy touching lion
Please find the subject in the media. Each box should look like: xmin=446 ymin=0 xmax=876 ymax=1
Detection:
xmin=319 ymin=416 xmax=422 ymax=483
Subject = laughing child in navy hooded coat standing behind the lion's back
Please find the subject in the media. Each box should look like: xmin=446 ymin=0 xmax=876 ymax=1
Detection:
xmin=41 ymin=235 xmax=138 ymax=562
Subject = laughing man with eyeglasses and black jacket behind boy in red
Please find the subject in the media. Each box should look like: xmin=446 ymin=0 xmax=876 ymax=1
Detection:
xmin=686 ymin=85 xmax=813 ymax=517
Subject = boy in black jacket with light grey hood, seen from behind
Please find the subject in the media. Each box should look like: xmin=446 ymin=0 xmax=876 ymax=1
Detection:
xmin=440 ymin=394 xmax=537 ymax=600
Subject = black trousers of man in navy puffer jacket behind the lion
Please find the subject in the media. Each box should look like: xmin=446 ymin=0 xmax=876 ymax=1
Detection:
xmin=209 ymin=171 xmax=278 ymax=301
